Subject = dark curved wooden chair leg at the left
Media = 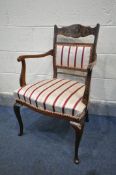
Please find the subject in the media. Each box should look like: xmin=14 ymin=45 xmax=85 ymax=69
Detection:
xmin=14 ymin=104 xmax=23 ymax=136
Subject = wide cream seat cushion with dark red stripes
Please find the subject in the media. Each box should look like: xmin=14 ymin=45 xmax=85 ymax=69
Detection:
xmin=14 ymin=78 xmax=85 ymax=116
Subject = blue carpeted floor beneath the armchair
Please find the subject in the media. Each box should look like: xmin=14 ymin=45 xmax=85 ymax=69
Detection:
xmin=0 ymin=106 xmax=116 ymax=175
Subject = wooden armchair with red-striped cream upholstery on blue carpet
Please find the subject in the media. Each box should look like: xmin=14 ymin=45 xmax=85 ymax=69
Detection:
xmin=14 ymin=24 xmax=100 ymax=164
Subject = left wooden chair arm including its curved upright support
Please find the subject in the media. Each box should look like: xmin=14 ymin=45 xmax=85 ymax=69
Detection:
xmin=17 ymin=50 xmax=53 ymax=87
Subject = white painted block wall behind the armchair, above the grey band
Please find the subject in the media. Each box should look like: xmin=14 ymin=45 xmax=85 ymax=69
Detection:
xmin=0 ymin=0 xmax=116 ymax=103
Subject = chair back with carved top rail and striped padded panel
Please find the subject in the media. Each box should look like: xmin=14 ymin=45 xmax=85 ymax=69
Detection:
xmin=53 ymin=24 xmax=99 ymax=77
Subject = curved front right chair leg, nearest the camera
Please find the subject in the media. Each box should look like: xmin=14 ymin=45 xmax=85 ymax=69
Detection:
xmin=70 ymin=122 xmax=84 ymax=164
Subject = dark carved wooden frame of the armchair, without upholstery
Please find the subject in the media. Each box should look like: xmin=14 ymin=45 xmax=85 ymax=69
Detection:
xmin=14 ymin=24 xmax=100 ymax=164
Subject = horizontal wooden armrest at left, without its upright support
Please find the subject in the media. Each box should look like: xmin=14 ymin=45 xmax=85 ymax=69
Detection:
xmin=17 ymin=49 xmax=53 ymax=61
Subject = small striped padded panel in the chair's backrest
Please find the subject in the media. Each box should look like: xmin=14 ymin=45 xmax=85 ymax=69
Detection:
xmin=56 ymin=44 xmax=92 ymax=69
